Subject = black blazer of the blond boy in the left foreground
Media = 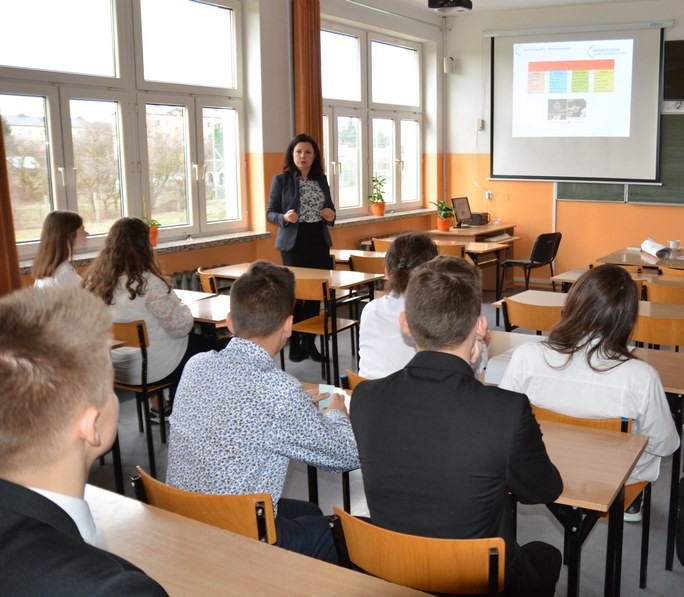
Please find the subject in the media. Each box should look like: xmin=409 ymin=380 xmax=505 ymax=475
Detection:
xmin=0 ymin=479 xmax=167 ymax=597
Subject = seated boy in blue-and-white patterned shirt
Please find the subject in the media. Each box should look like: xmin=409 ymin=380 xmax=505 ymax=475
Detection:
xmin=166 ymin=261 xmax=359 ymax=562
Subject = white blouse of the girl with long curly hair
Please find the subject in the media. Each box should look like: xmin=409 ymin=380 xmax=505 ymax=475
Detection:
xmin=110 ymin=273 xmax=194 ymax=384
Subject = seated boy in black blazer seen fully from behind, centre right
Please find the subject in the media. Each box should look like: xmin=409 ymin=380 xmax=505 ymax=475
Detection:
xmin=351 ymin=256 xmax=563 ymax=596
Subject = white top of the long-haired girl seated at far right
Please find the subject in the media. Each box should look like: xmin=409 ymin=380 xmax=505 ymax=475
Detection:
xmin=499 ymin=342 xmax=679 ymax=483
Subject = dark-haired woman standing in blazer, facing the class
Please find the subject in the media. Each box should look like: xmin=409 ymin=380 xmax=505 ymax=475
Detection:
xmin=266 ymin=134 xmax=335 ymax=362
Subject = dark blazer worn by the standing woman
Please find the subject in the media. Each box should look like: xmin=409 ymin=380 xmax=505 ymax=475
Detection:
xmin=266 ymin=172 xmax=335 ymax=251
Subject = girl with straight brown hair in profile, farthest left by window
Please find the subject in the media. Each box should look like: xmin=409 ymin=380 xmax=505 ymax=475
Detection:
xmin=31 ymin=210 xmax=88 ymax=288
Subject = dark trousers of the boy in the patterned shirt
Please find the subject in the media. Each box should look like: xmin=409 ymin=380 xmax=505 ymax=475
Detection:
xmin=276 ymin=498 xmax=337 ymax=564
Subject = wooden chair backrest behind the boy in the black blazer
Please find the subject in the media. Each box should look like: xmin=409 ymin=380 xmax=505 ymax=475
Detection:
xmin=331 ymin=507 xmax=506 ymax=595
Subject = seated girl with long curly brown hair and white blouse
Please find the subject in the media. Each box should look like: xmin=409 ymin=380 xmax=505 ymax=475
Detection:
xmin=84 ymin=218 xmax=195 ymax=414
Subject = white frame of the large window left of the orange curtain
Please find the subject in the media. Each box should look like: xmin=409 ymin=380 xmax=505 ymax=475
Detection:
xmin=0 ymin=0 xmax=249 ymax=259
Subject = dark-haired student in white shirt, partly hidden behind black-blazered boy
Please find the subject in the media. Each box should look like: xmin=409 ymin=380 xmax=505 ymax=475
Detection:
xmin=359 ymin=232 xmax=487 ymax=379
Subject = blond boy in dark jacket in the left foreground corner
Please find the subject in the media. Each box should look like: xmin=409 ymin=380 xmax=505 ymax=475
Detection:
xmin=0 ymin=288 xmax=166 ymax=597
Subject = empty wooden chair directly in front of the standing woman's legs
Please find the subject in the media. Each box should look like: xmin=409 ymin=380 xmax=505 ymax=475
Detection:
xmin=280 ymin=278 xmax=359 ymax=387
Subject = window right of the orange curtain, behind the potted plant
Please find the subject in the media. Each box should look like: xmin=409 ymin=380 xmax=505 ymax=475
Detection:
xmin=321 ymin=23 xmax=422 ymax=216
